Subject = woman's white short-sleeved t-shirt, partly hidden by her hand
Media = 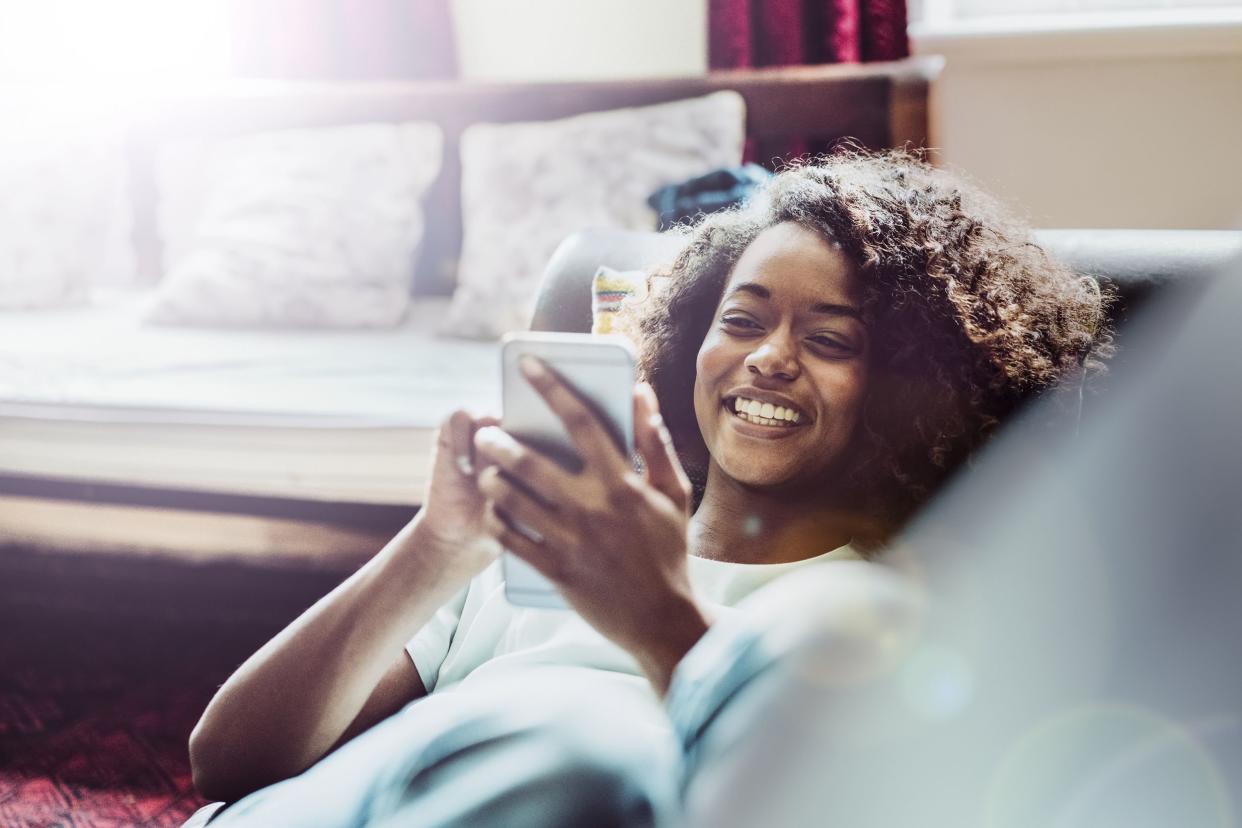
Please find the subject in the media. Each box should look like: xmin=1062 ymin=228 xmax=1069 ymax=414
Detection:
xmin=406 ymin=545 xmax=859 ymax=713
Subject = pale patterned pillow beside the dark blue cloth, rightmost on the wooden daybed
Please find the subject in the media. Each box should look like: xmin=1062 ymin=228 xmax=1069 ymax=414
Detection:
xmin=445 ymin=92 xmax=745 ymax=338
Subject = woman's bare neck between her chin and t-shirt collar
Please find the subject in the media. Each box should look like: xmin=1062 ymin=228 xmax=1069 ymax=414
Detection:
xmin=689 ymin=466 xmax=852 ymax=564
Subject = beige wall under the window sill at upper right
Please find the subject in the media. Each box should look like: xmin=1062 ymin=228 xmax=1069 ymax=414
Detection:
xmin=915 ymin=17 xmax=1242 ymax=228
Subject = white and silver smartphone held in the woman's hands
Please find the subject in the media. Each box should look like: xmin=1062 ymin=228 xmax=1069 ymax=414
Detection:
xmin=501 ymin=333 xmax=635 ymax=610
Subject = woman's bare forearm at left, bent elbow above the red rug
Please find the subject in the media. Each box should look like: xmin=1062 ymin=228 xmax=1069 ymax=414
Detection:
xmin=190 ymin=518 xmax=465 ymax=799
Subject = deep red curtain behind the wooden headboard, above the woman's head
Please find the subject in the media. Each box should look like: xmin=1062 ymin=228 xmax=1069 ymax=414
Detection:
xmin=708 ymin=0 xmax=909 ymax=70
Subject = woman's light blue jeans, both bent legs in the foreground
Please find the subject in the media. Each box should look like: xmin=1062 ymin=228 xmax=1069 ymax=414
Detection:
xmin=196 ymin=564 xmax=914 ymax=828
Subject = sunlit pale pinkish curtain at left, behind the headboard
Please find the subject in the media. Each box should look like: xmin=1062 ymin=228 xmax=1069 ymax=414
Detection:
xmin=230 ymin=0 xmax=457 ymax=81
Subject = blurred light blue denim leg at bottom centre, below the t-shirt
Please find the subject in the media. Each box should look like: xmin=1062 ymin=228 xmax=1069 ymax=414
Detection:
xmin=210 ymin=668 xmax=679 ymax=828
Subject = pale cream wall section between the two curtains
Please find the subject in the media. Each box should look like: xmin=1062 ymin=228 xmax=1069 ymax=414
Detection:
xmin=453 ymin=0 xmax=707 ymax=81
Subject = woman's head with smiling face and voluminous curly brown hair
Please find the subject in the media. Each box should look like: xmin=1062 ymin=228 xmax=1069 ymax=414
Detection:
xmin=641 ymin=153 xmax=1112 ymax=551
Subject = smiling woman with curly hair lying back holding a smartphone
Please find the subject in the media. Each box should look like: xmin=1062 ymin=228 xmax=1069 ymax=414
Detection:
xmin=183 ymin=154 xmax=1108 ymax=824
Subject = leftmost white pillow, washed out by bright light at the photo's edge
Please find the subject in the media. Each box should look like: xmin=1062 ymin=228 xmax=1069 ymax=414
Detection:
xmin=0 ymin=129 xmax=133 ymax=309
